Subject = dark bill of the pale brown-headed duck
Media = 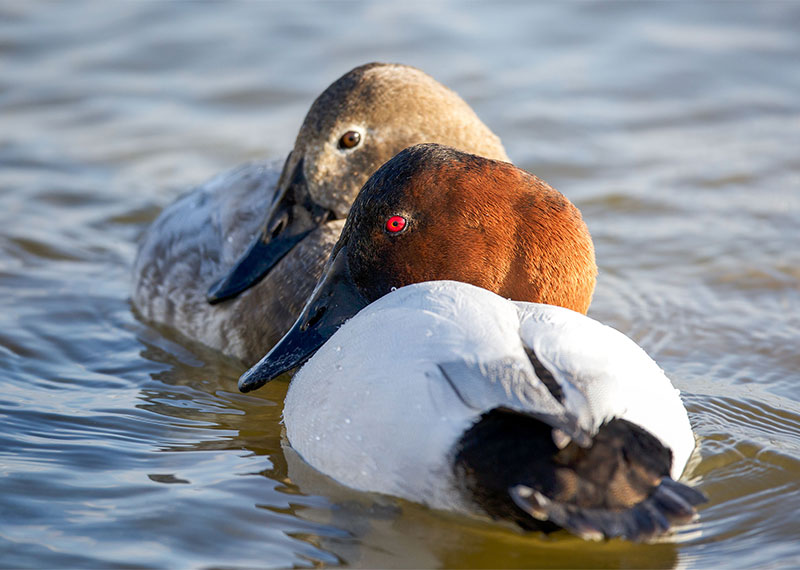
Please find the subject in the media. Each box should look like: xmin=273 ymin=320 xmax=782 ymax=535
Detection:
xmin=206 ymin=159 xmax=333 ymax=305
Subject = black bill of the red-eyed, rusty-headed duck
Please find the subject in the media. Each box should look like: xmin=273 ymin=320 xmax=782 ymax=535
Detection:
xmin=234 ymin=246 xmax=368 ymax=392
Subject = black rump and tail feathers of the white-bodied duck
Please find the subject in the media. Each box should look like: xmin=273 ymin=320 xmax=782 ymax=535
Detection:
xmin=454 ymin=408 xmax=705 ymax=541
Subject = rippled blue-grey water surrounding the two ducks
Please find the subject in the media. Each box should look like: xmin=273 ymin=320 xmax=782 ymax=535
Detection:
xmin=0 ymin=1 xmax=800 ymax=568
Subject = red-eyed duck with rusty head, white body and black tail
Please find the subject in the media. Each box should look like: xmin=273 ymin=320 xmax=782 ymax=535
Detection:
xmin=239 ymin=144 xmax=705 ymax=541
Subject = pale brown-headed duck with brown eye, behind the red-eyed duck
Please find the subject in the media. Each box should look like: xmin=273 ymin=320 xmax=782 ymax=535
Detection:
xmin=131 ymin=63 xmax=509 ymax=365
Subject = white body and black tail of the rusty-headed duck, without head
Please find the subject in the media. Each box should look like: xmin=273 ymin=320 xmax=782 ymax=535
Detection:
xmin=283 ymin=281 xmax=705 ymax=541
